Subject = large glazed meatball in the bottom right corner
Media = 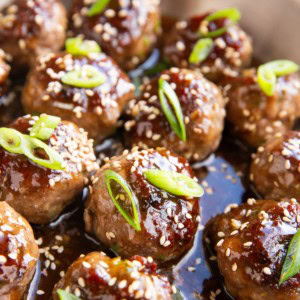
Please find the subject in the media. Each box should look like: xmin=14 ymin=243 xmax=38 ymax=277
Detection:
xmin=207 ymin=199 xmax=300 ymax=300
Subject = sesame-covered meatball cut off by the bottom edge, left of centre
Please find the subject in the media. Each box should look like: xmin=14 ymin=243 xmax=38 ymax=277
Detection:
xmin=53 ymin=252 xmax=172 ymax=300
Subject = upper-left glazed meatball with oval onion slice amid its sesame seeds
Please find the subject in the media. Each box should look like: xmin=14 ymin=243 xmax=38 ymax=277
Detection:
xmin=22 ymin=53 xmax=134 ymax=141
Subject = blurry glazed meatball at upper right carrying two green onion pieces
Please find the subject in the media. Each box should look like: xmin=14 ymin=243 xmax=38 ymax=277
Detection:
xmin=163 ymin=14 xmax=252 ymax=81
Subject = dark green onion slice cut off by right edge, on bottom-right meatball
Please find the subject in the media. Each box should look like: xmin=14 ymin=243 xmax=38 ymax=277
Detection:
xmin=279 ymin=229 xmax=300 ymax=285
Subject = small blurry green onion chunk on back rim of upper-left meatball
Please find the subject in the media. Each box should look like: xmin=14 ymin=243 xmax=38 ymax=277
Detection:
xmin=66 ymin=37 xmax=101 ymax=56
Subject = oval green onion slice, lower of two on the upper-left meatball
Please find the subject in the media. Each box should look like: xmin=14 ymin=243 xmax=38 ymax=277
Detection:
xmin=62 ymin=65 xmax=107 ymax=89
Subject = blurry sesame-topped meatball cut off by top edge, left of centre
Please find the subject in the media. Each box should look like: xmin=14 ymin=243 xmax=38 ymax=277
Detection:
xmin=71 ymin=0 xmax=161 ymax=70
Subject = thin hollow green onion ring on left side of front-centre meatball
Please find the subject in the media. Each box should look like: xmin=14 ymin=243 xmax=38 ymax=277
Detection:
xmin=104 ymin=170 xmax=141 ymax=231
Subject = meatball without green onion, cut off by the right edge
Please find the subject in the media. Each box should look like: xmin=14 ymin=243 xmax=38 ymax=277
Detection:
xmin=250 ymin=131 xmax=300 ymax=200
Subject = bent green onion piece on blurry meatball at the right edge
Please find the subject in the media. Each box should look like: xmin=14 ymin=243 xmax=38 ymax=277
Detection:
xmin=257 ymin=60 xmax=299 ymax=96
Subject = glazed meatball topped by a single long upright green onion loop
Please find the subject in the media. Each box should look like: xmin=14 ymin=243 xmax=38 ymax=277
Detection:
xmin=125 ymin=68 xmax=225 ymax=161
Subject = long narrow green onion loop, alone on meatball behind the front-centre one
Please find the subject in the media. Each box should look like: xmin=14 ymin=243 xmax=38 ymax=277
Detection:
xmin=158 ymin=78 xmax=186 ymax=142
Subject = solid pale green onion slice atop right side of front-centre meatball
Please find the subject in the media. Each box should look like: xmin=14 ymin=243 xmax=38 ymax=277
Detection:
xmin=145 ymin=169 xmax=204 ymax=197
